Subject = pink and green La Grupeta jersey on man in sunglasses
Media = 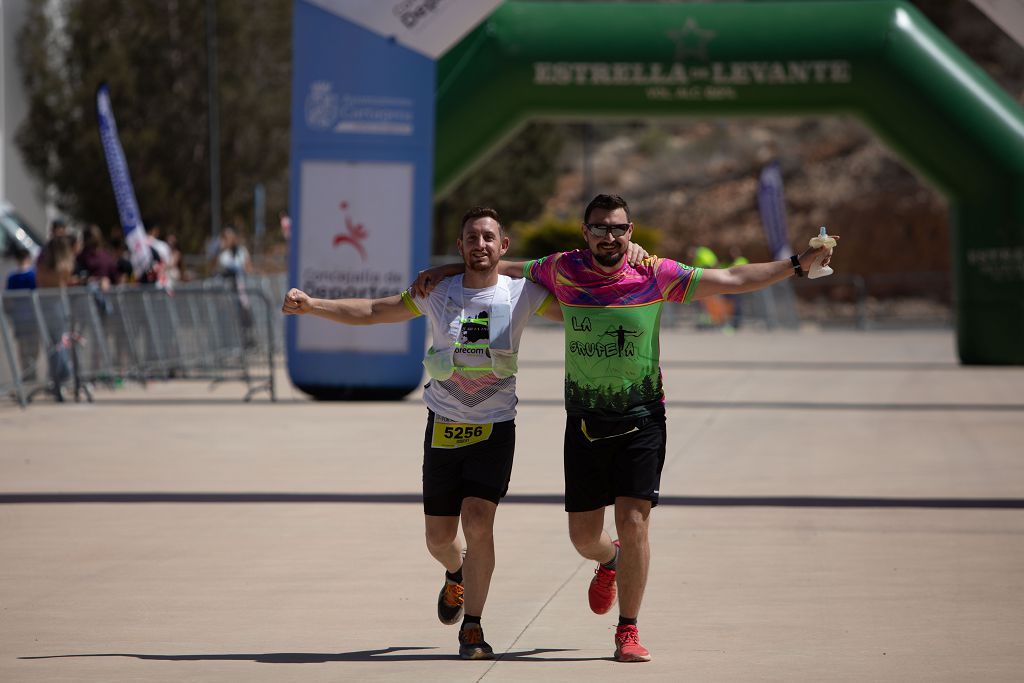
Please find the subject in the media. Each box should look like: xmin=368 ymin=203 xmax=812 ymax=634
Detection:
xmin=523 ymin=250 xmax=703 ymax=420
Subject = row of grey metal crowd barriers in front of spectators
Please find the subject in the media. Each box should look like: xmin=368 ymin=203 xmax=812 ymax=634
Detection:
xmin=0 ymin=278 xmax=285 ymax=405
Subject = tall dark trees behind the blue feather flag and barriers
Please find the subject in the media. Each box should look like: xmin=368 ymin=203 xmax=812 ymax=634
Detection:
xmin=17 ymin=0 xmax=292 ymax=250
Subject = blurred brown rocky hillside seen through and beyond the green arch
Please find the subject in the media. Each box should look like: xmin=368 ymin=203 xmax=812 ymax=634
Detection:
xmin=548 ymin=1 xmax=1024 ymax=282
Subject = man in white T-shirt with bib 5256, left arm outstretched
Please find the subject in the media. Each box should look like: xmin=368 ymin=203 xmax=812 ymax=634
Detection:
xmin=282 ymin=208 xmax=646 ymax=659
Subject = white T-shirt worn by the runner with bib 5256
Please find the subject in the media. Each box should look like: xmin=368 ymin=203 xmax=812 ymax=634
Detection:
xmin=403 ymin=275 xmax=554 ymax=424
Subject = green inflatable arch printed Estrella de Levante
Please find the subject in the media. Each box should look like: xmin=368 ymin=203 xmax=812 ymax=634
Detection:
xmin=435 ymin=1 xmax=1024 ymax=365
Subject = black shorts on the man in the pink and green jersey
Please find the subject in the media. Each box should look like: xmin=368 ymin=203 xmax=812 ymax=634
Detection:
xmin=564 ymin=413 xmax=666 ymax=512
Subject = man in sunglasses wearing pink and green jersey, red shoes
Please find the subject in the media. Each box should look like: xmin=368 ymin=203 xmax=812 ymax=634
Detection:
xmin=415 ymin=195 xmax=830 ymax=661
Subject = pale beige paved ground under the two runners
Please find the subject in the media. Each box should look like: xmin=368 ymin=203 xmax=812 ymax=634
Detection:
xmin=0 ymin=329 xmax=1024 ymax=682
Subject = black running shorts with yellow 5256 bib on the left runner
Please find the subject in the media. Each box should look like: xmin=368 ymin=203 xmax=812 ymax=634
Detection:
xmin=423 ymin=411 xmax=515 ymax=516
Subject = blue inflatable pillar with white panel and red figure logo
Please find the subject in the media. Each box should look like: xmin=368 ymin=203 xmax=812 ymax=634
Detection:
xmin=287 ymin=0 xmax=436 ymax=399
